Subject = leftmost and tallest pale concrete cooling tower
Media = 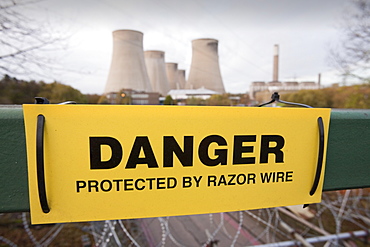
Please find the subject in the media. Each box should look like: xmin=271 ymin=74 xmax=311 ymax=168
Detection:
xmin=104 ymin=30 xmax=152 ymax=93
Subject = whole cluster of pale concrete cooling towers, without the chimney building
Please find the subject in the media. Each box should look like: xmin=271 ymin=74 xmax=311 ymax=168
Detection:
xmin=104 ymin=30 xmax=225 ymax=99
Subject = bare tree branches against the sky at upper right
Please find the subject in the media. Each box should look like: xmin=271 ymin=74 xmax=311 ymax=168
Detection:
xmin=329 ymin=0 xmax=370 ymax=82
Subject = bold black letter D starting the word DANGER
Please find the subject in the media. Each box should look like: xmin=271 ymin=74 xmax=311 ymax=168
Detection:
xmin=90 ymin=136 xmax=122 ymax=169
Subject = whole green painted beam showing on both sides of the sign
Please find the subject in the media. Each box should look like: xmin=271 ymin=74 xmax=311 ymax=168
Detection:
xmin=0 ymin=106 xmax=370 ymax=212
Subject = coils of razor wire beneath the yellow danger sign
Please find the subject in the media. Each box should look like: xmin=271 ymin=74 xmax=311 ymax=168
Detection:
xmin=0 ymin=189 xmax=370 ymax=247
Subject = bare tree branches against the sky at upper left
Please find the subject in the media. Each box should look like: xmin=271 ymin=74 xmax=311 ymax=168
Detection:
xmin=0 ymin=0 xmax=66 ymax=75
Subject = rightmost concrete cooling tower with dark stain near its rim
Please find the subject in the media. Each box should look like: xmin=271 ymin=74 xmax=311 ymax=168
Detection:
xmin=186 ymin=39 xmax=225 ymax=93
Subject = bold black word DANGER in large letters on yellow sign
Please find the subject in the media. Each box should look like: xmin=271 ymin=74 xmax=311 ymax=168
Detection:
xmin=89 ymin=135 xmax=286 ymax=170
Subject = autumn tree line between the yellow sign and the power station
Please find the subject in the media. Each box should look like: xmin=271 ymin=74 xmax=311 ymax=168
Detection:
xmin=0 ymin=75 xmax=370 ymax=109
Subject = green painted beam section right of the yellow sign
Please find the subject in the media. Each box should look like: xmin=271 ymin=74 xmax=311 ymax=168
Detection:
xmin=324 ymin=109 xmax=370 ymax=191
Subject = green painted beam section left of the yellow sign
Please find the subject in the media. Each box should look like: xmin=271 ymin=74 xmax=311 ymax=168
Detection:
xmin=0 ymin=107 xmax=30 ymax=213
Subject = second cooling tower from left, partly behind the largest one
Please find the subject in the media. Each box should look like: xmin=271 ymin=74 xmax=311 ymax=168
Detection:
xmin=144 ymin=51 xmax=170 ymax=96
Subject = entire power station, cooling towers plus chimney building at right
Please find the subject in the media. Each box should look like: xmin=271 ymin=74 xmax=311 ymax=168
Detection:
xmin=104 ymin=30 xmax=320 ymax=104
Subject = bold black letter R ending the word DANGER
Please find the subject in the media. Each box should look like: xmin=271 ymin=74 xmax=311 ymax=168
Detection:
xmin=260 ymin=135 xmax=285 ymax=163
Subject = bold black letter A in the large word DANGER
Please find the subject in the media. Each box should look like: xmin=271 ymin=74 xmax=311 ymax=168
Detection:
xmin=126 ymin=136 xmax=158 ymax=169
